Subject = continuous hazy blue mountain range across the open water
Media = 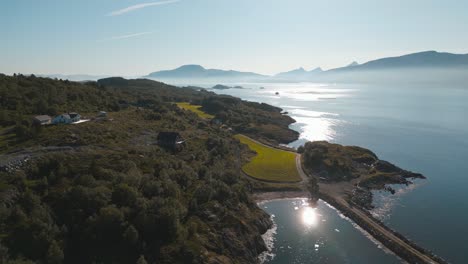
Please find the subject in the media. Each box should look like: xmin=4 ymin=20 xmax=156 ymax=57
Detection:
xmin=144 ymin=51 xmax=468 ymax=83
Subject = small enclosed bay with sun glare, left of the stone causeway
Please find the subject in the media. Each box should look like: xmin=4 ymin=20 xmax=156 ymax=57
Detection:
xmin=260 ymin=199 xmax=400 ymax=264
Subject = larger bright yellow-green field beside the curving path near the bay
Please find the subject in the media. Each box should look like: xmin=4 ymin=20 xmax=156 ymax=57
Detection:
xmin=234 ymin=135 xmax=301 ymax=182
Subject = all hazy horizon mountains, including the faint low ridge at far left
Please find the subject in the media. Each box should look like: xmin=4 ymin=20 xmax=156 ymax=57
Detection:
xmin=37 ymin=51 xmax=468 ymax=84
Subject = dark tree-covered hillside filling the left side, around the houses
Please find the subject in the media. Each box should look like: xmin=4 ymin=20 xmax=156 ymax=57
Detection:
xmin=0 ymin=75 xmax=297 ymax=263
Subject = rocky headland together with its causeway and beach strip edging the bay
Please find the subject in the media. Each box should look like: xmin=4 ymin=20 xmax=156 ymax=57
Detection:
xmin=253 ymin=139 xmax=447 ymax=264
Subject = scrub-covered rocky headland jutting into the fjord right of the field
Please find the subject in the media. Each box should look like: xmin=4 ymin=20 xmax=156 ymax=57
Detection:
xmin=301 ymin=141 xmax=424 ymax=209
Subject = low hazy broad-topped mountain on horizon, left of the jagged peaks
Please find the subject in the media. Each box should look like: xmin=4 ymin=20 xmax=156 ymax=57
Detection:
xmin=145 ymin=65 xmax=269 ymax=81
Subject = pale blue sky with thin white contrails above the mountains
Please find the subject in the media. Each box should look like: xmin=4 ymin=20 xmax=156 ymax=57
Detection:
xmin=0 ymin=0 xmax=468 ymax=76
